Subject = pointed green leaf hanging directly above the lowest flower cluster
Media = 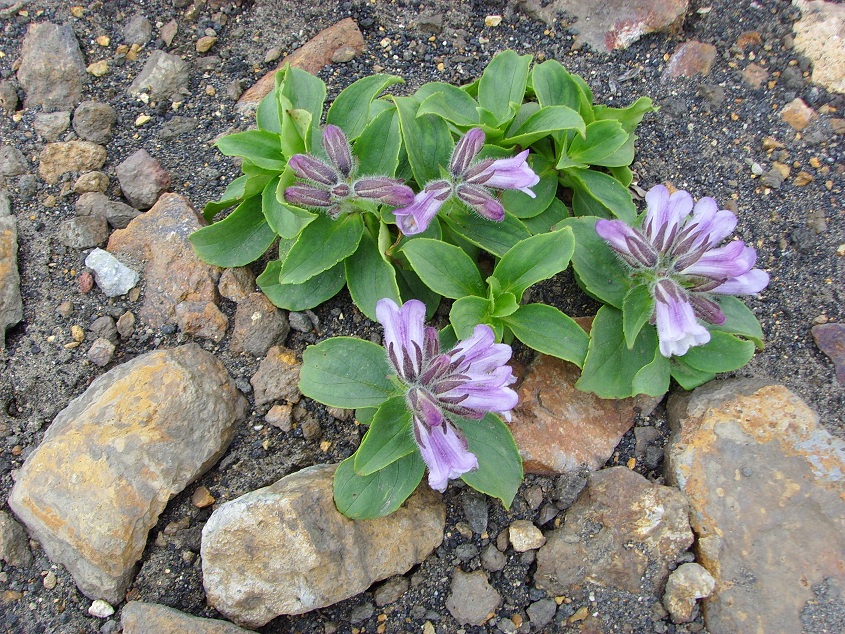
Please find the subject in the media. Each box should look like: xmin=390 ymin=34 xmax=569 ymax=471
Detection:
xmin=345 ymin=230 xmax=402 ymax=321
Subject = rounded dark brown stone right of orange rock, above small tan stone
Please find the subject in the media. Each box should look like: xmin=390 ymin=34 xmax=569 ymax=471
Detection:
xmin=229 ymin=293 xmax=290 ymax=357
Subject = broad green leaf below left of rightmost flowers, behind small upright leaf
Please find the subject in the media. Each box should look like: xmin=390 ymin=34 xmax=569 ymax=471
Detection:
xmin=575 ymin=306 xmax=657 ymax=398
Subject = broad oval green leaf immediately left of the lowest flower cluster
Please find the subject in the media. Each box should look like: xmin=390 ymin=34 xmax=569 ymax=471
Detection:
xmin=299 ymin=337 xmax=396 ymax=409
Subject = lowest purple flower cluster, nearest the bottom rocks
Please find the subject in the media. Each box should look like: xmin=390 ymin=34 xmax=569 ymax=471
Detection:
xmin=376 ymin=299 xmax=517 ymax=491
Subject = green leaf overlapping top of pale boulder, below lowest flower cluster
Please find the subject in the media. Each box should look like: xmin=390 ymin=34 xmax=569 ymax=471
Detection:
xmin=334 ymin=451 xmax=425 ymax=520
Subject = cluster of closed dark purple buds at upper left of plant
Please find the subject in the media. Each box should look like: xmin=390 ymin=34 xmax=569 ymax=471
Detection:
xmin=285 ymin=125 xmax=414 ymax=218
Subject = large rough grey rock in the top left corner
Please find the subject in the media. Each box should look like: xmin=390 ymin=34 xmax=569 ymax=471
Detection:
xmin=18 ymin=22 xmax=86 ymax=111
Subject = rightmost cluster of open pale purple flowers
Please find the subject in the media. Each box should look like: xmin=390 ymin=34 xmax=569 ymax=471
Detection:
xmin=596 ymin=185 xmax=769 ymax=357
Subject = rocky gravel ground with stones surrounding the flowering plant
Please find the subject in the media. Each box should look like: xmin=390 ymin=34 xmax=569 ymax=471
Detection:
xmin=0 ymin=0 xmax=845 ymax=634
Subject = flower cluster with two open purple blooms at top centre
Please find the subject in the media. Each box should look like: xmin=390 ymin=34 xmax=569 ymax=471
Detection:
xmin=393 ymin=128 xmax=540 ymax=235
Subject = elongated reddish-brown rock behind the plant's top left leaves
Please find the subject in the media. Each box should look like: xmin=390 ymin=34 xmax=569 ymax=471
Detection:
xmin=238 ymin=18 xmax=364 ymax=111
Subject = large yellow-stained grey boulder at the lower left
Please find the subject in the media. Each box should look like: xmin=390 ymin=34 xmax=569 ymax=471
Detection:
xmin=9 ymin=344 xmax=248 ymax=603
